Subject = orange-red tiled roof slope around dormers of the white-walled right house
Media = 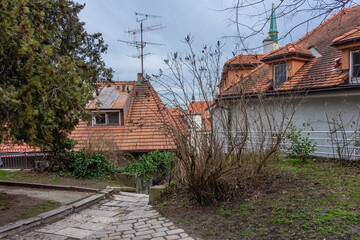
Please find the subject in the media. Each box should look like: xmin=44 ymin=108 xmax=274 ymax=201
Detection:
xmin=220 ymin=5 xmax=360 ymax=96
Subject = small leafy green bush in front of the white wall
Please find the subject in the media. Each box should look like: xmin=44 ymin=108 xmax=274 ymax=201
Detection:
xmin=286 ymin=123 xmax=316 ymax=160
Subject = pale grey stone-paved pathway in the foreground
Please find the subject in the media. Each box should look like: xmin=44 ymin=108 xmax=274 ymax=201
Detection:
xmin=8 ymin=192 xmax=193 ymax=240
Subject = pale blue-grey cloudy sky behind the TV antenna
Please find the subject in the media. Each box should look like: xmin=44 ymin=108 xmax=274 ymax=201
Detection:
xmin=77 ymin=0 xmax=326 ymax=81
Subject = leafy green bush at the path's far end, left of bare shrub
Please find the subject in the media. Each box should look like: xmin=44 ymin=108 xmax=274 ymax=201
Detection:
xmin=121 ymin=150 xmax=172 ymax=179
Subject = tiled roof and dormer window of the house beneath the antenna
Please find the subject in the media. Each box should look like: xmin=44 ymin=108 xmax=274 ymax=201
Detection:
xmin=70 ymin=81 xmax=176 ymax=154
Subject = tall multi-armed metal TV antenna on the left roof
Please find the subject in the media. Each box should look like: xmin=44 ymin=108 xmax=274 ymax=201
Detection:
xmin=118 ymin=12 xmax=166 ymax=81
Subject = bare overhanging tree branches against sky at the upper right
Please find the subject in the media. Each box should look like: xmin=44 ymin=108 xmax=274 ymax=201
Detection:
xmin=219 ymin=0 xmax=359 ymax=54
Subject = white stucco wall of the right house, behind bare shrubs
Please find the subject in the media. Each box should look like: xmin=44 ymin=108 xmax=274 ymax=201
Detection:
xmin=213 ymin=89 xmax=360 ymax=159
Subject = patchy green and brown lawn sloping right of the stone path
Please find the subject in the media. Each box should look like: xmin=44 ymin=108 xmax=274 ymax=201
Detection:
xmin=156 ymin=159 xmax=360 ymax=240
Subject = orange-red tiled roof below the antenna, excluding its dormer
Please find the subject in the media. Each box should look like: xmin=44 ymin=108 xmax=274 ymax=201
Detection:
xmin=70 ymin=82 xmax=175 ymax=152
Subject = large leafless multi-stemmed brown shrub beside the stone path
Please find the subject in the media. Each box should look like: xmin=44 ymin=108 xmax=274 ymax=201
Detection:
xmin=152 ymin=36 xmax=296 ymax=204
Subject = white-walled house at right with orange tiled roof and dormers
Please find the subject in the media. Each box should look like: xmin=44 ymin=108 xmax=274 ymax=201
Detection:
xmin=214 ymin=5 xmax=360 ymax=158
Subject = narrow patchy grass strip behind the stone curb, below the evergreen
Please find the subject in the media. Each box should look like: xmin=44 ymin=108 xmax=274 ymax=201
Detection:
xmin=0 ymin=170 xmax=131 ymax=189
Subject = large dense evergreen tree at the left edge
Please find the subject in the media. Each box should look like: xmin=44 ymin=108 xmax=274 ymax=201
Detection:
xmin=0 ymin=0 xmax=112 ymax=150
